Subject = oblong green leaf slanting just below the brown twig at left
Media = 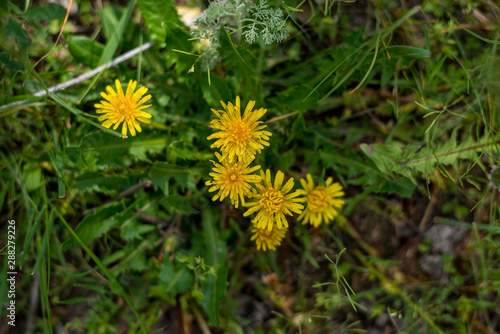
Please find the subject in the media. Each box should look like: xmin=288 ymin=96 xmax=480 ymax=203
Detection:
xmin=62 ymin=203 xmax=123 ymax=250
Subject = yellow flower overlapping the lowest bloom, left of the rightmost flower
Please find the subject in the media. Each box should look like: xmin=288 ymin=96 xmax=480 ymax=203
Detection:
xmin=243 ymin=169 xmax=304 ymax=231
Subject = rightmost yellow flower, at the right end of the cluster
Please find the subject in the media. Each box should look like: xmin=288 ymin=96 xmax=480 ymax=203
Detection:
xmin=297 ymin=174 xmax=345 ymax=227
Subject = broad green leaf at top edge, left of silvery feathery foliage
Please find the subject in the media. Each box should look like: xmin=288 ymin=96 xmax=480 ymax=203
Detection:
xmin=138 ymin=0 xmax=185 ymax=46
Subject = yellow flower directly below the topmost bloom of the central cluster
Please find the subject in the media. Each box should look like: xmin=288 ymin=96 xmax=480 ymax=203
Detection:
xmin=205 ymin=153 xmax=261 ymax=208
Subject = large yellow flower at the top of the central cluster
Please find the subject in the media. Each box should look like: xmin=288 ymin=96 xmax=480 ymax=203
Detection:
xmin=207 ymin=97 xmax=271 ymax=160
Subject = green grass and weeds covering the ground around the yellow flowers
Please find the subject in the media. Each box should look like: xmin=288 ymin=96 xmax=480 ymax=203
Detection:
xmin=0 ymin=0 xmax=500 ymax=334
